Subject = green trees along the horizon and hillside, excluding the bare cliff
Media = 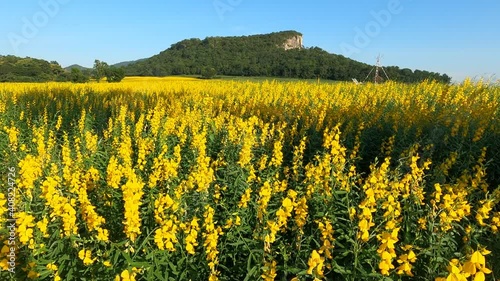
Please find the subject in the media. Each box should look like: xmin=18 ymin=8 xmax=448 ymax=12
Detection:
xmin=0 ymin=31 xmax=451 ymax=83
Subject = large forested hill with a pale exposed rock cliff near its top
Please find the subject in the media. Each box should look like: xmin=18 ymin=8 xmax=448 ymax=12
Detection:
xmin=125 ymin=31 xmax=451 ymax=83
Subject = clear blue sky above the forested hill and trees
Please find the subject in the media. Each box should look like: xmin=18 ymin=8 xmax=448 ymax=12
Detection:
xmin=0 ymin=0 xmax=500 ymax=81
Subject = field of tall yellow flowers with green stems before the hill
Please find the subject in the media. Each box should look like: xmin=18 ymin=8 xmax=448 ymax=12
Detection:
xmin=0 ymin=77 xmax=500 ymax=281
